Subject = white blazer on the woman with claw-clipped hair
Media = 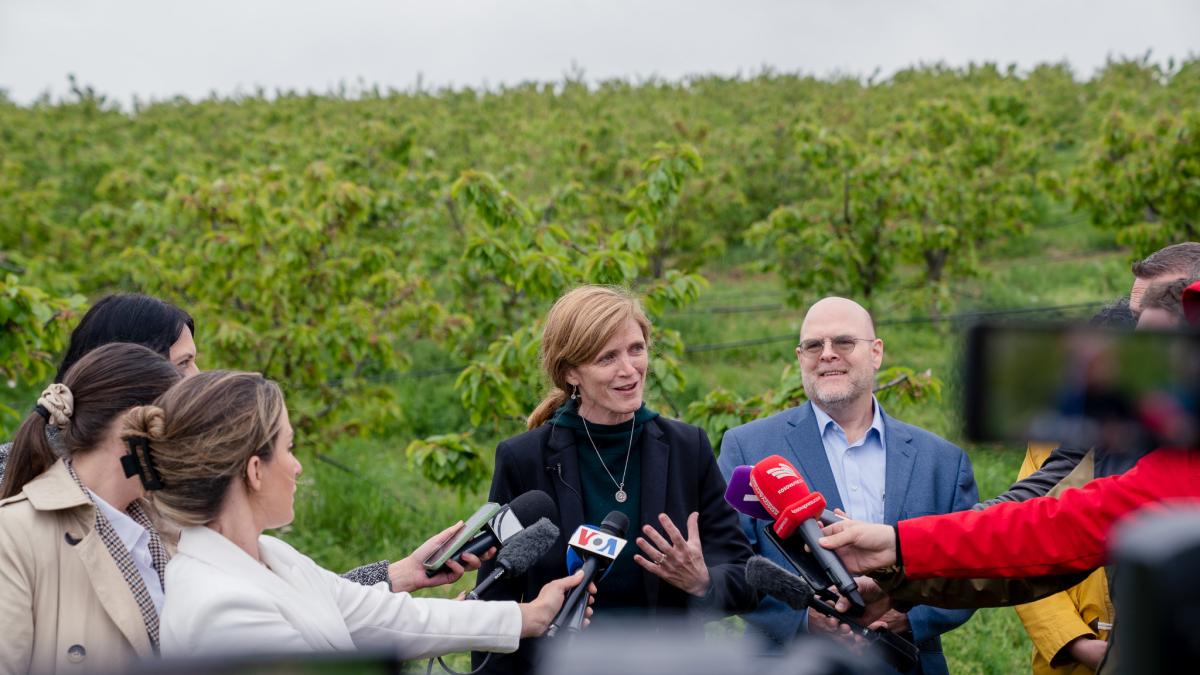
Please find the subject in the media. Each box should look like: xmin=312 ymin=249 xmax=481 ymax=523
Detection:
xmin=161 ymin=527 xmax=521 ymax=658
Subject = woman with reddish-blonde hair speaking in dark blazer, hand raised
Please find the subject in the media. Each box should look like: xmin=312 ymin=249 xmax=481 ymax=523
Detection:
xmin=475 ymin=286 xmax=756 ymax=673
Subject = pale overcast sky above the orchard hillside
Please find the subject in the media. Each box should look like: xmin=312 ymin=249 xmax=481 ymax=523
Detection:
xmin=0 ymin=0 xmax=1200 ymax=102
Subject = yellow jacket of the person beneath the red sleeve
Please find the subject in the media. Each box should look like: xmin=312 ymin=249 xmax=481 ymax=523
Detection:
xmin=1015 ymin=443 xmax=1114 ymax=675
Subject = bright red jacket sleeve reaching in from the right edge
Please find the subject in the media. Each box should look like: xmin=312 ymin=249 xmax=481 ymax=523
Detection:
xmin=896 ymin=449 xmax=1200 ymax=579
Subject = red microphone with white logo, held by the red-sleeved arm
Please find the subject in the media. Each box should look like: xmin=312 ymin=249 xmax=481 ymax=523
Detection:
xmin=750 ymin=455 xmax=866 ymax=616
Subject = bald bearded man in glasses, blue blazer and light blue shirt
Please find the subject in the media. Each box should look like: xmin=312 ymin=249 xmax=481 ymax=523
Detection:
xmin=718 ymin=298 xmax=979 ymax=674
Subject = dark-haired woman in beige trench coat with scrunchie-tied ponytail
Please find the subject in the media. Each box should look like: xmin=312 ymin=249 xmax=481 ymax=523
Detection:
xmin=0 ymin=344 xmax=180 ymax=673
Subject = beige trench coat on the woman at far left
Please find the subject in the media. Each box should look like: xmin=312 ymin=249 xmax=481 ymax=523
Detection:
xmin=0 ymin=460 xmax=154 ymax=674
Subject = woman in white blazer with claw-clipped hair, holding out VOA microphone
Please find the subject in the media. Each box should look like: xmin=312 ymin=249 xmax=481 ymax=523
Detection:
xmin=122 ymin=371 xmax=582 ymax=658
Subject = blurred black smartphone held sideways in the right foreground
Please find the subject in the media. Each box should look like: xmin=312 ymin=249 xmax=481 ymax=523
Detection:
xmin=964 ymin=324 xmax=1200 ymax=450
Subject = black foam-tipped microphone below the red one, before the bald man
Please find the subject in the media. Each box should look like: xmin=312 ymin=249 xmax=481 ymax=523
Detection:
xmin=746 ymin=555 xmax=919 ymax=673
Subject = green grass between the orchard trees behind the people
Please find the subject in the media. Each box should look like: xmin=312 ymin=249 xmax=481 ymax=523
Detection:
xmin=287 ymin=201 xmax=1128 ymax=674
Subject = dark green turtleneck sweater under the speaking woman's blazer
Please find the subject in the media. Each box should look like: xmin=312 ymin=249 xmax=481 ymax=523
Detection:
xmin=552 ymin=401 xmax=659 ymax=611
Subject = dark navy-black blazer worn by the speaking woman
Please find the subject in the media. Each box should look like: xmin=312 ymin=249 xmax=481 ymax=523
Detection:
xmin=474 ymin=417 xmax=757 ymax=673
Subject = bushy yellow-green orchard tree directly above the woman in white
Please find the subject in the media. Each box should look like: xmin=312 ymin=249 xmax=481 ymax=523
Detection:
xmin=113 ymin=162 xmax=446 ymax=448
